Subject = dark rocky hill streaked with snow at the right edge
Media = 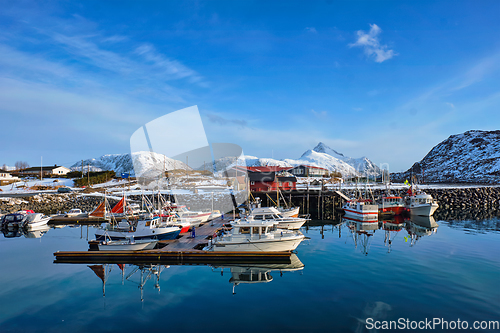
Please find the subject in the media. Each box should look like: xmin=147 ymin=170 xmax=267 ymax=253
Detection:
xmin=391 ymin=130 xmax=500 ymax=183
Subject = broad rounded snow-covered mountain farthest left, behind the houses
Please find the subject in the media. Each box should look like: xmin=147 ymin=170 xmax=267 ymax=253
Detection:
xmin=70 ymin=151 xmax=191 ymax=175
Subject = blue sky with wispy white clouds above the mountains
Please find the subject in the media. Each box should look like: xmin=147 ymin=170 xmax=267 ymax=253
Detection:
xmin=0 ymin=1 xmax=500 ymax=171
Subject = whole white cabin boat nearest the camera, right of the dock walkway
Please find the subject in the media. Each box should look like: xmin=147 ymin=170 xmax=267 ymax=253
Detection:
xmin=205 ymin=219 xmax=305 ymax=252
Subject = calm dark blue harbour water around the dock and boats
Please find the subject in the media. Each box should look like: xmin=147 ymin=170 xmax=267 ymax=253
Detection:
xmin=0 ymin=214 xmax=500 ymax=332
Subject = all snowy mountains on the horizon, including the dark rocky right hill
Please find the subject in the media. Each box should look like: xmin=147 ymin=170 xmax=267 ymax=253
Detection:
xmin=71 ymin=130 xmax=500 ymax=183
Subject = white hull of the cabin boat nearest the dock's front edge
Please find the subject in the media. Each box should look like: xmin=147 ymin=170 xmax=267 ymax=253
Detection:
xmin=213 ymin=235 xmax=304 ymax=252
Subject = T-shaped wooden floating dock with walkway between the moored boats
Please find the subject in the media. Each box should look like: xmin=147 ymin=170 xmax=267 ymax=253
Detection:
xmin=54 ymin=218 xmax=291 ymax=264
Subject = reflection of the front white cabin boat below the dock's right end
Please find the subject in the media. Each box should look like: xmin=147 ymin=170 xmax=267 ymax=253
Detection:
xmin=212 ymin=253 xmax=304 ymax=294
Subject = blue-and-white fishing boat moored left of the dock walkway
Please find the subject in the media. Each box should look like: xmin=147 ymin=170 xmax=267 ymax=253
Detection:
xmin=95 ymin=216 xmax=181 ymax=240
